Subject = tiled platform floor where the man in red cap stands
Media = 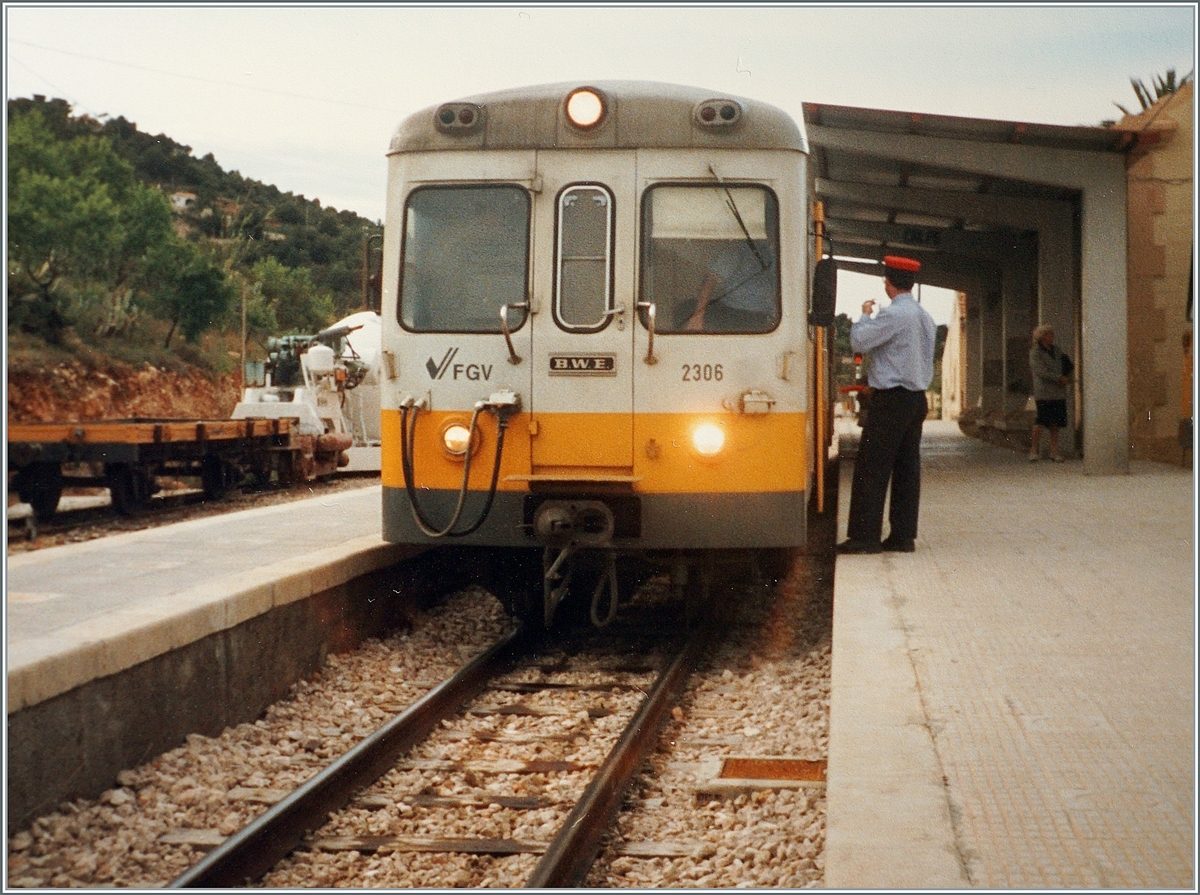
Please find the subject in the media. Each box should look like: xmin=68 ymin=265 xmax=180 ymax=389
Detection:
xmin=824 ymin=421 xmax=1196 ymax=891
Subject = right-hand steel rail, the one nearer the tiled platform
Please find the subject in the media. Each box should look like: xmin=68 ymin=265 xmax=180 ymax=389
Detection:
xmin=526 ymin=625 xmax=710 ymax=889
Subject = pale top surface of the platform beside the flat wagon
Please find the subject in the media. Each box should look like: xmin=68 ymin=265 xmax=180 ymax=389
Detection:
xmin=5 ymin=483 xmax=398 ymax=713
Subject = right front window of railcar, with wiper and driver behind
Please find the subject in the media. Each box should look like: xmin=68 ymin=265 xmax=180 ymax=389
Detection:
xmin=641 ymin=184 xmax=781 ymax=334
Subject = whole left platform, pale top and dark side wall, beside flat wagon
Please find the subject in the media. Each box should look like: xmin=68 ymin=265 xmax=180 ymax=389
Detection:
xmin=5 ymin=485 xmax=430 ymax=833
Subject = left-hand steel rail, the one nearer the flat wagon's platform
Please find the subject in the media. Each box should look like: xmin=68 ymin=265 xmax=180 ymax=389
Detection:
xmin=168 ymin=626 xmax=530 ymax=889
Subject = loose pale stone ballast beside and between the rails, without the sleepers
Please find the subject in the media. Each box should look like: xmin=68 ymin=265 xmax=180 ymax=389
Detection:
xmin=7 ymin=544 xmax=832 ymax=888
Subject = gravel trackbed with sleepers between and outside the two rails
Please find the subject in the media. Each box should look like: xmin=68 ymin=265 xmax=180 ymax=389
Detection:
xmin=8 ymin=536 xmax=832 ymax=888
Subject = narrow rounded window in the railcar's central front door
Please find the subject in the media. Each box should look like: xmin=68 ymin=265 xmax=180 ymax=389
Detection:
xmin=554 ymin=185 xmax=613 ymax=331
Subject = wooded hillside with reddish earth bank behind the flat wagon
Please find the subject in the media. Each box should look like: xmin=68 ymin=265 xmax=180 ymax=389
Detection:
xmin=6 ymin=96 xmax=382 ymax=422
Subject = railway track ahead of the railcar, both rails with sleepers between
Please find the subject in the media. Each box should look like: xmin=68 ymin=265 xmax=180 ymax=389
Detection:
xmin=172 ymin=602 xmax=707 ymax=888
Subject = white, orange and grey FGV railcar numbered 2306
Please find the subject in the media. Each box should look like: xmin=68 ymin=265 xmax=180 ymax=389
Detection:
xmin=382 ymin=82 xmax=832 ymax=620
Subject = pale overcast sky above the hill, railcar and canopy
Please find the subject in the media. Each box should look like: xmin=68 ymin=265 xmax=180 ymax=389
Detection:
xmin=5 ymin=4 xmax=1195 ymax=317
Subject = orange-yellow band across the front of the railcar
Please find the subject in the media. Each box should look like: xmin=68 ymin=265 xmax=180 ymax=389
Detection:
xmin=382 ymin=410 xmax=808 ymax=493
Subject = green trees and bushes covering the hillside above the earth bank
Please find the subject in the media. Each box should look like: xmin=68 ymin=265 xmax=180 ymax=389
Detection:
xmin=7 ymin=95 xmax=377 ymax=356
